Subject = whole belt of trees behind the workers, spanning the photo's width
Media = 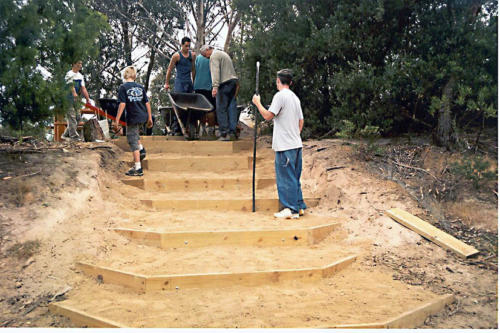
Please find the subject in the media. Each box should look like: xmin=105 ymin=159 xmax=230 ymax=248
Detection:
xmin=0 ymin=0 xmax=498 ymax=146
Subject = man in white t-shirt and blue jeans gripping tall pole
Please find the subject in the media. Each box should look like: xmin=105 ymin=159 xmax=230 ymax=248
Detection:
xmin=252 ymin=69 xmax=307 ymax=219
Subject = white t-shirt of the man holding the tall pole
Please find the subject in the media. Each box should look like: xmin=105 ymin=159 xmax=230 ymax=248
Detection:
xmin=269 ymin=88 xmax=304 ymax=151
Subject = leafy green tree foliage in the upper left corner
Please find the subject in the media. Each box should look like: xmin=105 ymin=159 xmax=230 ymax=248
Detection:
xmin=0 ymin=0 xmax=106 ymax=129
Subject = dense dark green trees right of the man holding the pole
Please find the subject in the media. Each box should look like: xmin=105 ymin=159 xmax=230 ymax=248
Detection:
xmin=234 ymin=0 xmax=498 ymax=135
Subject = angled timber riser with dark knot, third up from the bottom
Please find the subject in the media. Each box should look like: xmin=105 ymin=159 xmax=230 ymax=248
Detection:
xmin=114 ymin=223 xmax=339 ymax=249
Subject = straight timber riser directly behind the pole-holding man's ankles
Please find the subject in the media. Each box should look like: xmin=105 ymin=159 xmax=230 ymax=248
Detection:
xmin=141 ymin=198 xmax=319 ymax=212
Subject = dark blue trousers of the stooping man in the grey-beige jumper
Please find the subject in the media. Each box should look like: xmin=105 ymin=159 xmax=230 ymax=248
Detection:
xmin=215 ymin=80 xmax=238 ymax=136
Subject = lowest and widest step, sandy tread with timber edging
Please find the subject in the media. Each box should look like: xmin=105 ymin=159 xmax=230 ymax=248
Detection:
xmin=49 ymin=263 xmax=454 ymax=329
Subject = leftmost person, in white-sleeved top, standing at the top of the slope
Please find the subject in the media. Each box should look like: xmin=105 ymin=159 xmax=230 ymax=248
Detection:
xmin=61 ymin=60 xmax=90 ymax=140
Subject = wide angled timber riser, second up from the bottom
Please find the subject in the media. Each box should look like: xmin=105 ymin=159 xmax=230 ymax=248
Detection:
xmin=77 ymin=256 xmax=356 ymax=292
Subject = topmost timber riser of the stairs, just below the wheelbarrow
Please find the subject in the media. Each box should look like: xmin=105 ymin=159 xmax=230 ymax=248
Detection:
xmin=113 ymin=136 xmax=253 ymax=155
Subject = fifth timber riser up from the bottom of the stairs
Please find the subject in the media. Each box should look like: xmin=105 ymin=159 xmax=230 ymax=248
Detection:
xmin=122 ymin=178 xmax=276 ymax=192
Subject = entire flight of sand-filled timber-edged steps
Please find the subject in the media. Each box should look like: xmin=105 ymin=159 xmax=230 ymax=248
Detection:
xmin=49 ymin=137 xmax=453 ymax=328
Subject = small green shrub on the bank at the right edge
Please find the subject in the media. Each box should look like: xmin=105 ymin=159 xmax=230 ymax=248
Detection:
xmin=451 ymin=155 xmax=498 ymax=189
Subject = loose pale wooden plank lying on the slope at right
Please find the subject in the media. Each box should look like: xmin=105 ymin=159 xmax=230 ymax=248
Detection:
xmin=386 ymin=208 xmax=479 ymax=258
